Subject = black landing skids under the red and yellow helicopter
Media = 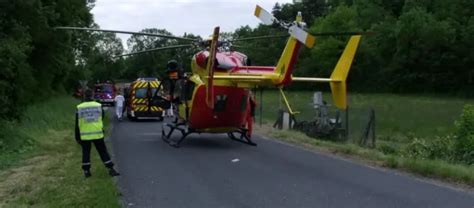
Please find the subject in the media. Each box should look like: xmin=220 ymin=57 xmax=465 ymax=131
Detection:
xmin=161 ymin=123 xmax=257 ymax=148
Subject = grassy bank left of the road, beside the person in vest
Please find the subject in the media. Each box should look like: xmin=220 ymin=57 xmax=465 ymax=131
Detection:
xmin=0 ymin=97 xmax=119 ymax=207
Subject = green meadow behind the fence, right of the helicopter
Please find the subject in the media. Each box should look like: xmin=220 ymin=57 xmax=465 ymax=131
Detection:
xmin=257 ymin=91 xmax=468 ymax=140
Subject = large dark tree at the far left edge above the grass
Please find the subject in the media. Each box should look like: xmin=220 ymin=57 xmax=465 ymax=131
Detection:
xmin=0 ymin=0 xmax=92 ymax=118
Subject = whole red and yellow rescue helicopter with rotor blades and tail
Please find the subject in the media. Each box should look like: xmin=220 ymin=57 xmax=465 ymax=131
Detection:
xmin=57 ymin=5 xmax=362 ymax=147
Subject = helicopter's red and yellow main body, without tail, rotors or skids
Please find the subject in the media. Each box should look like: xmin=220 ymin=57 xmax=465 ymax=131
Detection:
xmin=172 ymin=51 xmax=258 ymax=133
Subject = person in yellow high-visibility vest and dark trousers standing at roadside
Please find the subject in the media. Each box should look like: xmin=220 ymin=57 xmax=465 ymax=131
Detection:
xmin=75 ymin=90 xmax=120 ymax=178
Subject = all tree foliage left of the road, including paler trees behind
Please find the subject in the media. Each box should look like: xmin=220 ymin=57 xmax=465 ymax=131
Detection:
xmin=0 ymin=0 xmax=123 ymax=119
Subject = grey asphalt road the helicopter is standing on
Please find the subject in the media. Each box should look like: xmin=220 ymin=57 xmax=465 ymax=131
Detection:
xmin=112 ymin=114 xmax=474 ymax=208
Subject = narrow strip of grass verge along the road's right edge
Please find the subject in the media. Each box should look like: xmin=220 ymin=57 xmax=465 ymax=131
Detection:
xmin=256 ymin=125 xmax=474 ymax=188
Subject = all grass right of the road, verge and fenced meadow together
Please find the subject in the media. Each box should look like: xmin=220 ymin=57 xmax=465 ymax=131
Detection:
xmin=257 ymin=91 xmax=474 ymax=186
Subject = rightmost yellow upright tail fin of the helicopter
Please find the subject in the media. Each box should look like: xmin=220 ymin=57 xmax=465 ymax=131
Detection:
xmin=330 ymin=35 xmax=361 ymax=109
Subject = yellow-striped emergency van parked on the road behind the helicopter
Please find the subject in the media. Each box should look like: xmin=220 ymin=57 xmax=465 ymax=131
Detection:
xmin=126 ymin=78 xmax=163 ymax=120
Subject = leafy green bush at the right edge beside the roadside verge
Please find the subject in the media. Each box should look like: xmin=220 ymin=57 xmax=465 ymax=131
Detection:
xmin=403 ymin=105 xmax=474 ymax=165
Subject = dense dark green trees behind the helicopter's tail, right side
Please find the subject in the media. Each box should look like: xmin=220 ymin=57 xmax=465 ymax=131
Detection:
xmin=236 ymin=0 xmax=474 ymax=94
